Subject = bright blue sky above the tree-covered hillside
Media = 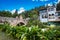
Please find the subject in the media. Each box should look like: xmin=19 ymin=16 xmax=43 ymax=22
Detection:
xmin=0 ymin=0 xmax=57 ymax=10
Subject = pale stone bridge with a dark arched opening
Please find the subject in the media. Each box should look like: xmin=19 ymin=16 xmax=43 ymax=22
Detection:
xmin=0 ymin=15 xmax=29 ymax=26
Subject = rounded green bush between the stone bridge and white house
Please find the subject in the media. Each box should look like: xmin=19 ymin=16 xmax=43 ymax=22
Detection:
xmin=26 ymin=19 xmax=47 ymax=28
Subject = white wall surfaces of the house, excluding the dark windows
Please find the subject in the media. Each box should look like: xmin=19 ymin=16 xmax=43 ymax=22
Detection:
xmin=39 ymin=7 xmax=56 ymax=22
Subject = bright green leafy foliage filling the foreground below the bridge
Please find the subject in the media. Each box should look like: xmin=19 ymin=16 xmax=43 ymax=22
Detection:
xmin=0 ymin=24 xmax=60 ymax=40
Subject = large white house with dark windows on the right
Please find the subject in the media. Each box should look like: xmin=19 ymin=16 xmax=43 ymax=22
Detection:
xmin=39 ymin=5 xmax=60 ymax=22
